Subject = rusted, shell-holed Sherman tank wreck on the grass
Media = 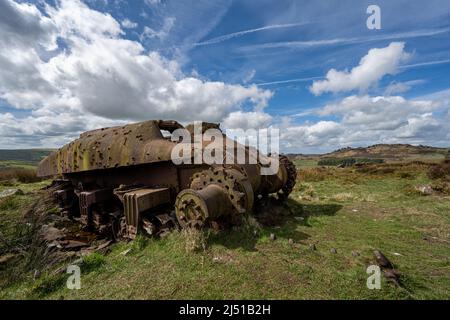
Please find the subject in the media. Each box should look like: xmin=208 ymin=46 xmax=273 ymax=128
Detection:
xmin=37 ymin=120 xmax=296 ymax=239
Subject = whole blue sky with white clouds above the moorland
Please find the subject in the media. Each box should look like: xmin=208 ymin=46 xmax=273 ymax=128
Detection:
xmin=0 ymin=0 xmax=450 ymax=152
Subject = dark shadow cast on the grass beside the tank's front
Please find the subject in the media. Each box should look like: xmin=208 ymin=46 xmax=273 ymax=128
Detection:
xmin=208 ymin=199 xmax=342 ymax=251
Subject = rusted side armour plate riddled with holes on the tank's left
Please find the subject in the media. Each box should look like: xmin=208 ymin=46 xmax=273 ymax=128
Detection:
xmin=37 ymin=120 xmax=181 ymax=177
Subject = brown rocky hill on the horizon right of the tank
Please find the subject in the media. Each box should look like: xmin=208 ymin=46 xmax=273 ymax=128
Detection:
xmin=321 ymin=144 xmax=450 ymax=161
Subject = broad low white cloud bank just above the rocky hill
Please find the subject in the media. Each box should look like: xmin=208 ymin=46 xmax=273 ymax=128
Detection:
xmin=281 ymin=93 xmax=450 ymax=153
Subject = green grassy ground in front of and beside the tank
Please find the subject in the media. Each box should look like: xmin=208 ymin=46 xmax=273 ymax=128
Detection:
xmin=0 ymin=165 xmax=450 ymax=299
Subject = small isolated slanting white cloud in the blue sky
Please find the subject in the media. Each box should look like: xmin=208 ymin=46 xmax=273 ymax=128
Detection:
xmin=310 ymin=42 xmax=410 ymax=96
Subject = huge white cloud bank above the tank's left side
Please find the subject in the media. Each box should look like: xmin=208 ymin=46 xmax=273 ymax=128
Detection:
xmin=0 ymin=0 xmax=272 ymax=147
